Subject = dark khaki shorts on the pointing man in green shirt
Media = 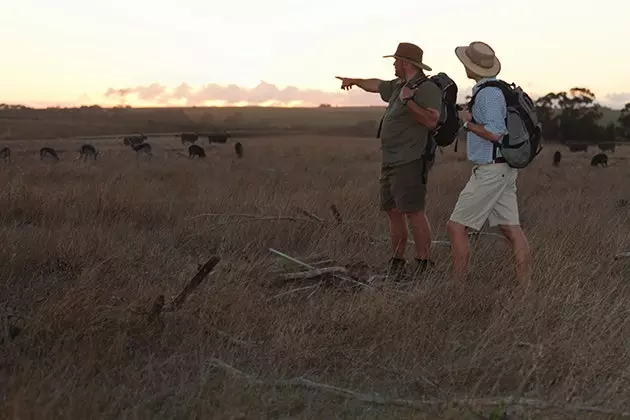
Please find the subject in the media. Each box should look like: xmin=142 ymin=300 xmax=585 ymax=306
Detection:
xmin=380 ymin=157 xmax=433 ymax=213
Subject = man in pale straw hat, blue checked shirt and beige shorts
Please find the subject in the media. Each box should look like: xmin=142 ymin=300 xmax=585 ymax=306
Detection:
xmin=447 ymin=41 xmax=530 ymax=289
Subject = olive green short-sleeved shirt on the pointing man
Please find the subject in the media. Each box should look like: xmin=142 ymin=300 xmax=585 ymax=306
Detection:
xmin=379 ymin=74 xmax=442 ymax=166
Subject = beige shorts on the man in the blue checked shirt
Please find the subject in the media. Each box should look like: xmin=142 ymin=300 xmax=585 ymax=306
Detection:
xmin=450 ymin=163 xmax=520 ymax=230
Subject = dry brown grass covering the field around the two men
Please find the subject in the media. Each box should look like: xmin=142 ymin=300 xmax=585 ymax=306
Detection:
xmin=0 ymin=136 xmax=630 ymax=419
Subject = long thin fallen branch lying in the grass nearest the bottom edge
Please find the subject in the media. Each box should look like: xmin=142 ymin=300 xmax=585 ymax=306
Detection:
xmin=210 ymin=358 xmax=630 ymax=418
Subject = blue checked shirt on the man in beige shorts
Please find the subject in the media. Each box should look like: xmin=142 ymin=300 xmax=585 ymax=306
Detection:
xmin=466 ymin=77 xmax=507 ymax=165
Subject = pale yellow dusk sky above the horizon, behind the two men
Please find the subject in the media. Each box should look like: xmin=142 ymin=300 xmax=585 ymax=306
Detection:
xmin=0 ymin=0 xmax=630 ymax=108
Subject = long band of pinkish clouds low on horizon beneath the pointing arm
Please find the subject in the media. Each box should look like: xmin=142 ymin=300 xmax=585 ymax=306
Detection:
xmin=105 ymin=81 xmax=386 ymax=106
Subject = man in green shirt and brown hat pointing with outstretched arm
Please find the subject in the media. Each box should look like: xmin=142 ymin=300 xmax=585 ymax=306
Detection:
xmin=337 ymin=42 xmax=442 ymax=280
